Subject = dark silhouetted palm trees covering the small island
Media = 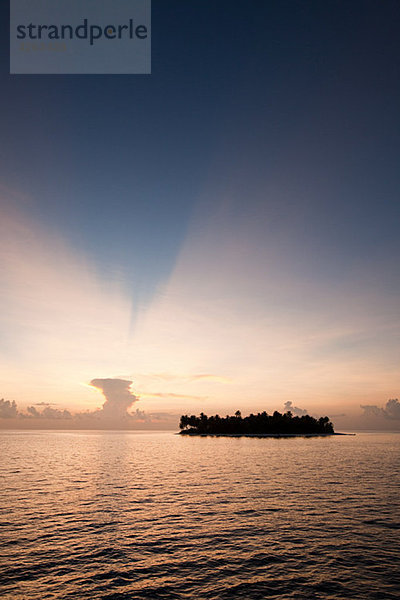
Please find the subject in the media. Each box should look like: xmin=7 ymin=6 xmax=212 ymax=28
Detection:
xmin=179 ymin=410 xmax=334 ymax=434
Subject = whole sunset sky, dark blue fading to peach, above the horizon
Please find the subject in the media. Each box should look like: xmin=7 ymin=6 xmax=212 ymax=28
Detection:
xmin=0 ymin=0 xmax=400 ymax=430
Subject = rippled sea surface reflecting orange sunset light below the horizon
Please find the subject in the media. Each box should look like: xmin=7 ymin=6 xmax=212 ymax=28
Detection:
xmin=0 ymin=432 xmax=400 ymax=600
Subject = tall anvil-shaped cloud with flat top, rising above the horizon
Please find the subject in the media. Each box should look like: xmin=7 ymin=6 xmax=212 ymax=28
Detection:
xmin=90 ymin=379 xmax=139 ymax=419
